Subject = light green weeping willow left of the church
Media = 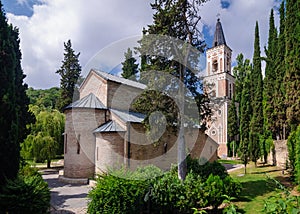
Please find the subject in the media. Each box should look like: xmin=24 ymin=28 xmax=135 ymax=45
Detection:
xmin=21 ymin=105 xmax=65 ymax=168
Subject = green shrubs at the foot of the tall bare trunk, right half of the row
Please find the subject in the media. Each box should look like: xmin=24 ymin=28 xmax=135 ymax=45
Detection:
xmin=151 ymin=171 xmax=241 ymax=213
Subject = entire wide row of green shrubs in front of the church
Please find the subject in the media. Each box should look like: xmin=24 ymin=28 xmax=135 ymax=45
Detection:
xmin=88 ymin=159 xmax=241 ymax=213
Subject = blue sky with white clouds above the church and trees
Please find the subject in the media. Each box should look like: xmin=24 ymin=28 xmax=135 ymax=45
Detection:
xmin=2 ymin=0 xmax=280 ymax=88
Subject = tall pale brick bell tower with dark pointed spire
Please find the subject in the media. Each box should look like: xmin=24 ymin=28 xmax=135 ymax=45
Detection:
xmin=204 ymin=18 xmax=235 ymax=158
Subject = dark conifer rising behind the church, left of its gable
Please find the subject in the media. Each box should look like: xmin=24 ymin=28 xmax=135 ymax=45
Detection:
xmin=56 ymin=40 xmax=81 ymax=110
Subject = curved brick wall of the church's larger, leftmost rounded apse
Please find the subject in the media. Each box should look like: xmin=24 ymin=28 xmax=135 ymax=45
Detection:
xmin=64 ymin=109 xmax=105 ymax=178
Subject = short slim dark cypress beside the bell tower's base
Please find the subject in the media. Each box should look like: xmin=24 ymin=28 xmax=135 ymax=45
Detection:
xmin=227 ymin=96 xmax=239 ymax=157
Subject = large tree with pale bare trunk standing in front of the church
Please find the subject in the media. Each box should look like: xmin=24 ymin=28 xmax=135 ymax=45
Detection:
xmin=136 ymin=0 xmax=209 ymax=180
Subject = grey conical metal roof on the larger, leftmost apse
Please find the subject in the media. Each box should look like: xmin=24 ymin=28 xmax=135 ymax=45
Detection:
xmin=64 ymin=93 xmax=107 ymax=110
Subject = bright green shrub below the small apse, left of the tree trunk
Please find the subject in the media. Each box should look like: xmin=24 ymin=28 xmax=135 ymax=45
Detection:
xmin=88 ymin=166 xmax=161 ymax=214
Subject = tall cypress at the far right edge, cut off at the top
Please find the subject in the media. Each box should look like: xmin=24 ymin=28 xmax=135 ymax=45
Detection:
xmin=284 ymin=0 xmax=300 ymax=131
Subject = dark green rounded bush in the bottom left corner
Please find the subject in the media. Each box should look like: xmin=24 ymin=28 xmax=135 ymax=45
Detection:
xmin=0 ymin=166 xmax=50 ymax=214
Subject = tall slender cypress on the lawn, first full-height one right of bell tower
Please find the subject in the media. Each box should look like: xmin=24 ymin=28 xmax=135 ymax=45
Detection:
xmin=249 ymin=22 xmax=264 ymax=165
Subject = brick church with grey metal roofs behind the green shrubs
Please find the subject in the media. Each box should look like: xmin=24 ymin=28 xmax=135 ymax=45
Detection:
xmin=61 ymin=69 xmax=218 ymax=181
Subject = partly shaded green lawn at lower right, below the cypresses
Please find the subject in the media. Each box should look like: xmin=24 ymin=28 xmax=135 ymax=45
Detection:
xmin=230 ymin=163 xmax=289 ymax=214
